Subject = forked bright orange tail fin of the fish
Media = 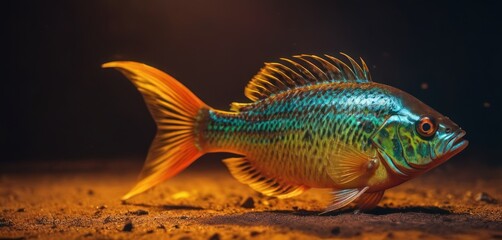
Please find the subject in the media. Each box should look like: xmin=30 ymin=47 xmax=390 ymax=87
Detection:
xmin=102 ymin=62 xmax=208 ymax=200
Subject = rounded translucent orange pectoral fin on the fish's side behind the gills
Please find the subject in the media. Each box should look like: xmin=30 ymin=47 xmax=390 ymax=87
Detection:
xmin=327 ymin=147 xmax=379 ymax=185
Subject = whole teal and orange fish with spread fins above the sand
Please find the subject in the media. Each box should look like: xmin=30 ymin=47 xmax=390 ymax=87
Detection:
xmin=102 ymin=53 xmax=469 ymax=213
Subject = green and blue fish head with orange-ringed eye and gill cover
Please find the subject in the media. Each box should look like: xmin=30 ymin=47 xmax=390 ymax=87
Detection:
xmin=372 ymin=91 xmax=468 ymax=176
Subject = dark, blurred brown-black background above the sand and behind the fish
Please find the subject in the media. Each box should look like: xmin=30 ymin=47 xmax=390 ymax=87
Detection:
xmin=0 ymin=0 xmax=502 ymax=164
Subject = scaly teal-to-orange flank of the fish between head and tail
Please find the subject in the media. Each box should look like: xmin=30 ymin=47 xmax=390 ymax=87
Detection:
xmin=202 ymin=83 xmax=391 ymax=187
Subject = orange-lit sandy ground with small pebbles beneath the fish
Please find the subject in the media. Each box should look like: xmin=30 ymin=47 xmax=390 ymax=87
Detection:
xmin=0 ymin=159 xmax=502 ymax=240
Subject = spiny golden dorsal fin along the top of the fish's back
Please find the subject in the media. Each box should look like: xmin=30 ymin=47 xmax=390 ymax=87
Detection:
xmin=244 ymin=53 xmax=371 ymax=101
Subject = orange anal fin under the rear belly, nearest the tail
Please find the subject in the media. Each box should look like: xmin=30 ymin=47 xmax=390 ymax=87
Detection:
xmin=223 ymin=158 xmax=309 ymax=198
